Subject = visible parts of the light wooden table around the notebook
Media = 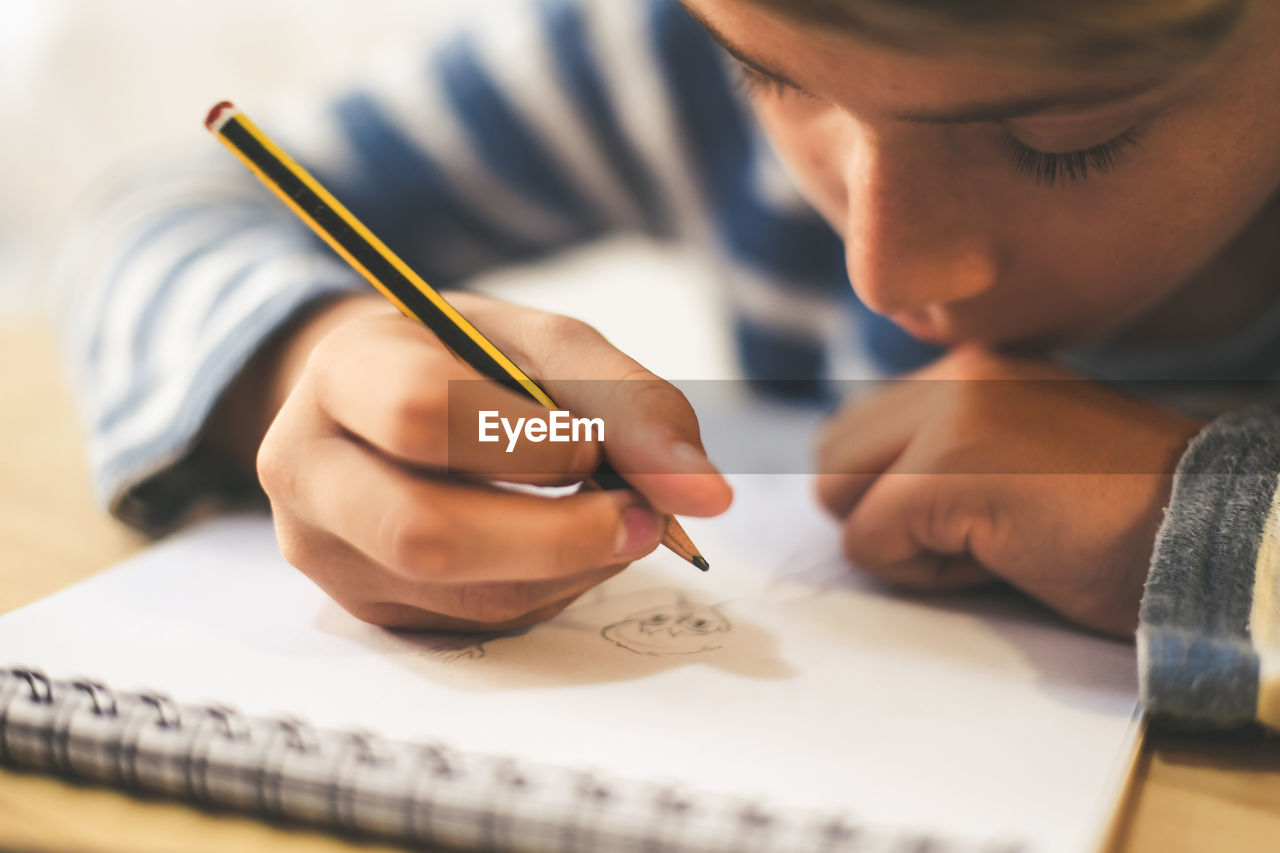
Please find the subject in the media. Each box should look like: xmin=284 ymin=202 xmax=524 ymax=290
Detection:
xmin=0 ymin=321 xmax=1280 ymax=853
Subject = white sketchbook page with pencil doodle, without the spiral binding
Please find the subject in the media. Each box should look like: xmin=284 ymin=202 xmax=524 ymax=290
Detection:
xmin=0 ymin=475 xmax=1137 ymax=850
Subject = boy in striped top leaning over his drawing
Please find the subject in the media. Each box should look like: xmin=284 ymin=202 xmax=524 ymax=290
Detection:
xmin=60 ymin=0 xmax=1280 ymax=726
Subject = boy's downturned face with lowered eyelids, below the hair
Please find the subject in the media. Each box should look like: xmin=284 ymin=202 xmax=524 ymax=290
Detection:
xmin=685 ymin=0 xmax=1280 ymax=346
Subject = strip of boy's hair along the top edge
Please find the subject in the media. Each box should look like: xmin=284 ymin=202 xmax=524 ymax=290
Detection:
xmin=750 ymin=0 xmax=1248 ymax=65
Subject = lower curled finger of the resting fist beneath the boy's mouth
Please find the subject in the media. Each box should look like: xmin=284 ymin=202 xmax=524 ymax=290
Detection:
xmin=842 ymin=473 xmax=993 ymax=589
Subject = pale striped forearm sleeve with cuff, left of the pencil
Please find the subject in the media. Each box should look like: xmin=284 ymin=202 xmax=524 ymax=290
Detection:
xmin=54 ymin=152 xmax=366 ymax=530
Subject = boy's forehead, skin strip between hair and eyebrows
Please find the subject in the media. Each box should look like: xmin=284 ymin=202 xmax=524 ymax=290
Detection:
xmin=684 ymin=0 xmax=1167 ymax=114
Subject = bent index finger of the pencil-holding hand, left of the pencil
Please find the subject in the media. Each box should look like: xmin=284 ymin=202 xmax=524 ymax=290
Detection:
xmin=308 ymin=316 xmax=600 ymax=485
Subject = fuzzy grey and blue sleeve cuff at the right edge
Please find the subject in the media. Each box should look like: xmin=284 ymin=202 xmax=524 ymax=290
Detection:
xmin=1138 ymin=405 xmax=1280 ymax=729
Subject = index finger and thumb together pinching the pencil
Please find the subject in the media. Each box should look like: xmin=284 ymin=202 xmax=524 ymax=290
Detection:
xmin=308 ymin=295 xmax=732 ymax=515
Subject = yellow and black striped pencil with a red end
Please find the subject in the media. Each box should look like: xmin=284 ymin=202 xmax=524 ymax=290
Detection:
xmin=205 ymin=101 xmax=710 ymax=571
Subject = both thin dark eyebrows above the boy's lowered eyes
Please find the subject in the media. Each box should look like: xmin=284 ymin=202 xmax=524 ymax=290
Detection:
xmin=681 ymin=1 xmax=1156 ymax=124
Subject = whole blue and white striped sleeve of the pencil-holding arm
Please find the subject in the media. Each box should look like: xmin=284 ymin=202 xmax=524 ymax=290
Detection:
xmin=56 ymin=0 xmax=732 ymax=530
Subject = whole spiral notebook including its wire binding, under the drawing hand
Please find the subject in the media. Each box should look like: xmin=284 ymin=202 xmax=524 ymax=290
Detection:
xmin=0 ymin=475 xmax=1137 ymax=853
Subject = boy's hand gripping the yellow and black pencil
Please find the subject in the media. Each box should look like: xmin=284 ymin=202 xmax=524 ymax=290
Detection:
xmin=211 ymin=108 xmax=730 ymax=630
